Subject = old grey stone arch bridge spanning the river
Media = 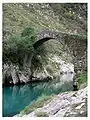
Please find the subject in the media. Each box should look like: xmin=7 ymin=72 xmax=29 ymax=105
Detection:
xmin=33 ymin=30 xmax=87 ymax=88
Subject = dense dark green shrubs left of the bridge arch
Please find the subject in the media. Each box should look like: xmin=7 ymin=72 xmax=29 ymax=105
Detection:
xmin=3 ymin=26 xmax=36 ymax=65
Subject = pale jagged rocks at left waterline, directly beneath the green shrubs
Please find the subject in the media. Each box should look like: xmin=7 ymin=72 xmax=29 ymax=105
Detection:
xmin=3 ymin=64 xmax=30 ymax=85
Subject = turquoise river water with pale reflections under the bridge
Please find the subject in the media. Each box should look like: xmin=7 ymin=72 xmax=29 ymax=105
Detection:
xmin=3 ymin=74 xmax=73 ymax=117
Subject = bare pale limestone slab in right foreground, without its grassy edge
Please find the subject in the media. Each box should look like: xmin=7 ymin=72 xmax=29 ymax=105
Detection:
xmin=21 ymin=88 xmax=87 ymax=117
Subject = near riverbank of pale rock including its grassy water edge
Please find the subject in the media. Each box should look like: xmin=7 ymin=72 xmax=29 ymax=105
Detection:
xmin=15 ymin=87 xmax=87 ymax=117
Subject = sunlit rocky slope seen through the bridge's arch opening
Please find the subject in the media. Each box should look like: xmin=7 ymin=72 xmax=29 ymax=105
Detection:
xmin=32 ymin=39 xmax=74 ymax=80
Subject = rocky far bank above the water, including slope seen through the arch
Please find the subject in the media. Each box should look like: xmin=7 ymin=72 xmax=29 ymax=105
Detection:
xmin=3 ymin=40 xmax=74 ymax=84
